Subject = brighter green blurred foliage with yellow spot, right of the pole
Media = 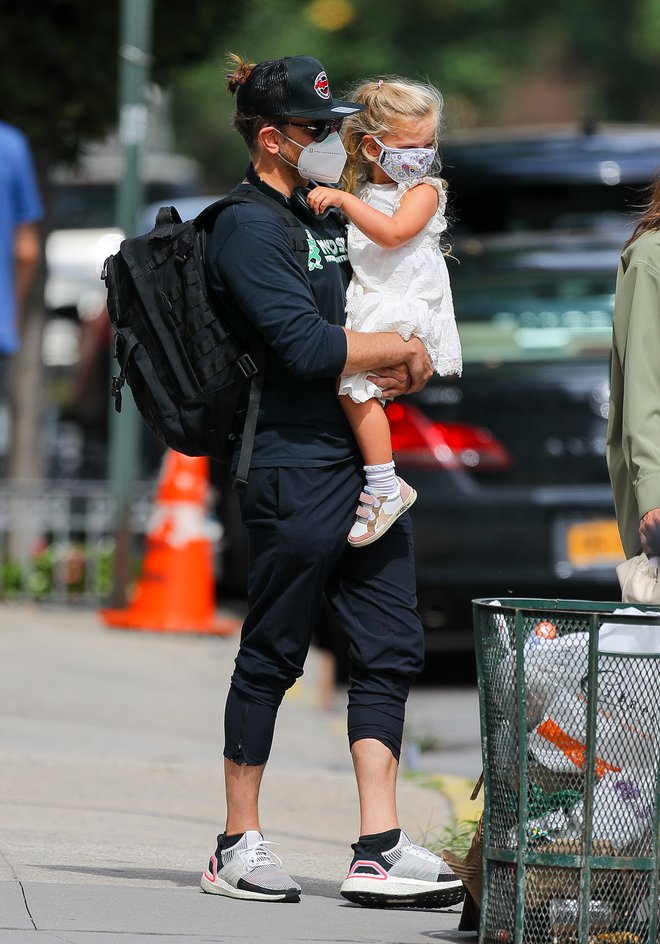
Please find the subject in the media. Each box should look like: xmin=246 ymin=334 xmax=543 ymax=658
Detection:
xmin=175 ymin=0 xmax=660 ymax=189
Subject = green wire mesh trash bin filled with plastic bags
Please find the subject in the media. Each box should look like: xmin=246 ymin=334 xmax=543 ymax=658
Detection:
xmin=473 ymin=599 xmax=660 ymax=944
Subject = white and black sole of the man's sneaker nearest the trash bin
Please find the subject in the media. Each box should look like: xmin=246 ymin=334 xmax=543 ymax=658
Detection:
xmin=340 ymin=878 xmax=465 ymax=908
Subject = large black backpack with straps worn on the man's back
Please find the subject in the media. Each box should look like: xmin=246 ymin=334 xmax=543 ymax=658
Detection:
xmin=101 ymin=185 xmax=308 ymax=484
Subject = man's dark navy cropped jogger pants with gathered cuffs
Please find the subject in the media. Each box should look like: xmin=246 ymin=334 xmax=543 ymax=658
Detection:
xmin=224 ymin=462 xmax=424 ymax=764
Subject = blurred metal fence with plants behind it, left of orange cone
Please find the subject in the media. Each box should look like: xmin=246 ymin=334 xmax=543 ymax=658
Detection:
xmin=0 ymin=481 xmax=155 ymax=606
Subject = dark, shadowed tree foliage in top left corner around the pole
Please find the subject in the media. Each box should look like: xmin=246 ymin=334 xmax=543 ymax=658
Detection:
xmin=0 ymin=0 xmax=240 ymax=167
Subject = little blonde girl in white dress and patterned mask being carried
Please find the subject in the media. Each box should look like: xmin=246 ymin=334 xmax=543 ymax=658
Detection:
xmin=307 ymin=77 xmax=462 ymax=547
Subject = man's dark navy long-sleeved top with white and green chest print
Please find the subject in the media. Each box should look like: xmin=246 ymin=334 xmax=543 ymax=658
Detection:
xmin=206 ymin=170 xmax=357 ymax=468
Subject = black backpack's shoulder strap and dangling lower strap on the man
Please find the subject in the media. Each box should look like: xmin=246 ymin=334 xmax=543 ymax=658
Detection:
xmin=195 ymin=184 xmax=309 ymax=488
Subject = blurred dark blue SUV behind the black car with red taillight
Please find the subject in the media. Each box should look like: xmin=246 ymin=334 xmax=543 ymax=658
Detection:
xmin=441 ymin=126 xmax=660 ymax=238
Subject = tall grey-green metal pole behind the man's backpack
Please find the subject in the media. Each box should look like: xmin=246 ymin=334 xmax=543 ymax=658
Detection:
xmin=110 ymin=0 xmax=153 ymax=607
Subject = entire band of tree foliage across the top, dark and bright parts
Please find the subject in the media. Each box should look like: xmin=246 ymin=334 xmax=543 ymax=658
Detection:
xmin=0 ymin=0 xmax=660 ymax=179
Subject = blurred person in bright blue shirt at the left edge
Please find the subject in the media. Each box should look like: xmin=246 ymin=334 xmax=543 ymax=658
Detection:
xmin=0 ymin=121 xmax=43 ymax=400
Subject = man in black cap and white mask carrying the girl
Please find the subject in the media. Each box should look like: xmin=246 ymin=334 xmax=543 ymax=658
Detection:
xmin=201 ymin=56 xmax=463 ymax=905
